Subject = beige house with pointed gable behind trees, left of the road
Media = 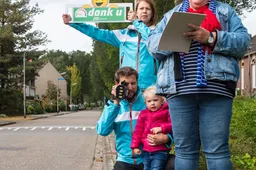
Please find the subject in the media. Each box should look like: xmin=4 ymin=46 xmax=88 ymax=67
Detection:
xmin=35 ymin=62 xmax=68 ymax=103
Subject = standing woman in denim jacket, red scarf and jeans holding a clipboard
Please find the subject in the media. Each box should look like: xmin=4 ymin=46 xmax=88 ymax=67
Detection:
xmin=147 ymin=0 xmax=250 ymax=170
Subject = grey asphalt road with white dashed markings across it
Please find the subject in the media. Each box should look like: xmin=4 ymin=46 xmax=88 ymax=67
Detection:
xmin=0 ymin=111 xmax=100 ymax=170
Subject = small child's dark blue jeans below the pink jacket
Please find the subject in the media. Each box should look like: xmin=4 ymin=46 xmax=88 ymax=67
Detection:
xmin=143 ymin=151 xmax=169 ymax=170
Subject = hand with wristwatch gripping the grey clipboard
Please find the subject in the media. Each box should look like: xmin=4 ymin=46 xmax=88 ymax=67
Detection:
xmin=184 ymin=24 xmax=216 ymax=44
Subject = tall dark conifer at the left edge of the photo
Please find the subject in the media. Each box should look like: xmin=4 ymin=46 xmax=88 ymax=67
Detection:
xmin=0 ymin=0 xmax=47 ymax=114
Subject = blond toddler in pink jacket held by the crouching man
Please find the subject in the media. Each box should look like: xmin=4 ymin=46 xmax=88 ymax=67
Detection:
xmin=131 ymin=86 xmax=172 ymax=170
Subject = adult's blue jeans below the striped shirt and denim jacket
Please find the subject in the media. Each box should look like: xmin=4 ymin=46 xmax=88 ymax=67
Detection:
xmin=168 ymin=94 xmax=233 ymax=170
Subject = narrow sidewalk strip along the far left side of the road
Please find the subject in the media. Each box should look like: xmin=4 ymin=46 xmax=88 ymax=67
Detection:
xmin=0 ymin=112 xmax=73 ymax=126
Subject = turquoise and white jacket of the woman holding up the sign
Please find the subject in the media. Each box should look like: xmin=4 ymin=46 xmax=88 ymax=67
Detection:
xmin=70 ymin=23 xmax=158 ymax=89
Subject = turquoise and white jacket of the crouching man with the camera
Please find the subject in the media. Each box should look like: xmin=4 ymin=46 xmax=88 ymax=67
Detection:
xmin=96 ymin=90 xmax=146 ymax=164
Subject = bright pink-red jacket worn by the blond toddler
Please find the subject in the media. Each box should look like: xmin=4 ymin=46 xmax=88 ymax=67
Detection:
xmin=131 ymin=103 xmax=172 ymax=152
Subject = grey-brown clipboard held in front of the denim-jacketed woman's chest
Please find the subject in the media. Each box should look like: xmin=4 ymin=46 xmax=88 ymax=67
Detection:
xmin=159 ymin=12 xmax=206 ymax=53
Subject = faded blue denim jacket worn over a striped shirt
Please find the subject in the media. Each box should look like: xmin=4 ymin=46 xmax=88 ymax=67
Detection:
xmin=146 ymin=2 xmax=250 ymax=95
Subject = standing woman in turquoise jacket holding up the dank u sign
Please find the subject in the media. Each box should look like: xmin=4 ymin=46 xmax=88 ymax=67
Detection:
xmin=62 ymin=0 xmax=158 ymax=90
